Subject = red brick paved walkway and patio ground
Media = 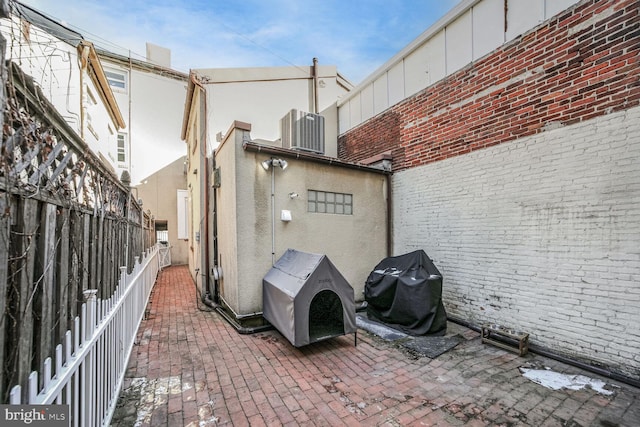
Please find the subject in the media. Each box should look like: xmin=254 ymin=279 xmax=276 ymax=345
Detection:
xmin=112 ymin=267 xmax=640 ymax=427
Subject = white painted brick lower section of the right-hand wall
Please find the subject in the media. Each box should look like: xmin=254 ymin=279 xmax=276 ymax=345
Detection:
xmin=393 ymin=107 xmax=640 ymax=378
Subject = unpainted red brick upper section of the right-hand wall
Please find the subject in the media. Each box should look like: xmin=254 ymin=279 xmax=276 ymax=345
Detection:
xmin=338 ymin=0 xmax=640 ymax=170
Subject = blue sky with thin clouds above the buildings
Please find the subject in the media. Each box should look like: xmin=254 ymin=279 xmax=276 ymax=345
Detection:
xmin=22 ymin=0 xmax=459 ymax=84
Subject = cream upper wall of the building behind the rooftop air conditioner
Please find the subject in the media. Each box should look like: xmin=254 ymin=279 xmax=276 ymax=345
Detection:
xmin=193 ymin=65 xmax=351 ymax=157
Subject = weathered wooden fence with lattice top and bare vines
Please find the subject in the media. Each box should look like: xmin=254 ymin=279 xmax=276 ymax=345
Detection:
xmin=0 ymin=63 xmax=155 ymax=402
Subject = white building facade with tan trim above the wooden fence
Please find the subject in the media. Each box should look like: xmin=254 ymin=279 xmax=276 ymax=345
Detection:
xmin=0 ymin=3 xmax=126 ymax=173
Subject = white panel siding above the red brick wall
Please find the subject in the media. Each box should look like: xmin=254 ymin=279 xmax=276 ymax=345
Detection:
xmin=338 ymin=0 xmax=579 ymax=133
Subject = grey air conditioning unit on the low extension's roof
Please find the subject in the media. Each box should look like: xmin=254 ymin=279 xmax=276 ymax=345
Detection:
xmin=280 ymin=109 xmax=324 ymax=154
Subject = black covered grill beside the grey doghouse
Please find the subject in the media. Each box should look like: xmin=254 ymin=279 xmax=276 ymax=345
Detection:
xmin=364 ymin=250 xmax=447 ymax=336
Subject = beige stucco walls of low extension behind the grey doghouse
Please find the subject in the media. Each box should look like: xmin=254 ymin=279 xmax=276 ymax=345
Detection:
xmin=216 ymin=125 xmax=387 ymax=315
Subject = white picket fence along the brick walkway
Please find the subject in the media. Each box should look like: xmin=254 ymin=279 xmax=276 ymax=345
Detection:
xmin=9 ymin=245 xmax=160 ymax=426
